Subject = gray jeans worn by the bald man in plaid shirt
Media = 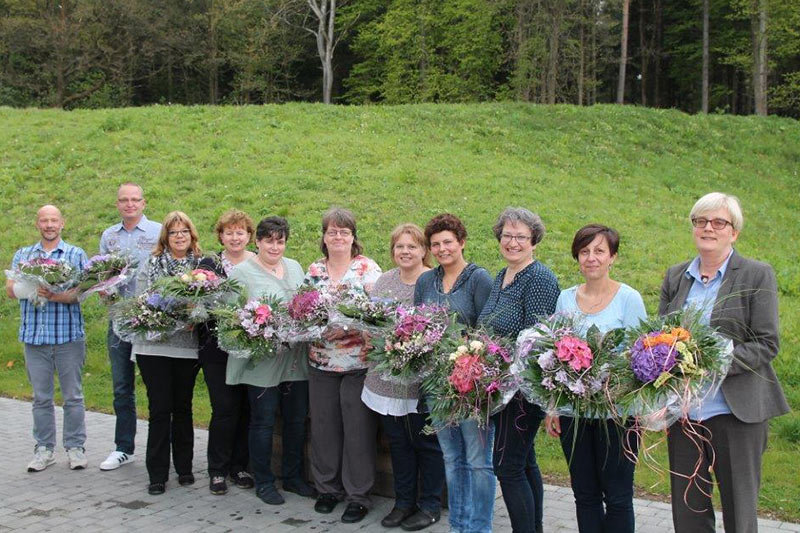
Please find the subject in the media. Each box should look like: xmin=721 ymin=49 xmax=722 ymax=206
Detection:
xmin=25 ymin=339 xmax=86 ymax=450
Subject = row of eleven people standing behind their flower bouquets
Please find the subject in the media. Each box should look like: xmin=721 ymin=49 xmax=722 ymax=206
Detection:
xmin=6 ymin=183 xmax=789 ymax=533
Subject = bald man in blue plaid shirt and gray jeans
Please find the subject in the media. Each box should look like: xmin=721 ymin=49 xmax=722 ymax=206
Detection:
xmin=6 ymin=205 xmax=88 ymax=472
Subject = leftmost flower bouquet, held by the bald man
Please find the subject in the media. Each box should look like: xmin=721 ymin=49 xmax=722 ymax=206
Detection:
xmin=5 ymin=257 xmax=79 ymax=307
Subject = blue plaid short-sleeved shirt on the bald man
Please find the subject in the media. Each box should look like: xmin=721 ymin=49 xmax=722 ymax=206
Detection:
xmin=11 ymin=241 xmax=88 ymax=345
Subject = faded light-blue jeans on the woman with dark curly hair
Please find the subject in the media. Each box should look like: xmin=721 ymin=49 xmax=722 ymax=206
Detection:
xmin=437 ymin=420 xmax=497 ymax=533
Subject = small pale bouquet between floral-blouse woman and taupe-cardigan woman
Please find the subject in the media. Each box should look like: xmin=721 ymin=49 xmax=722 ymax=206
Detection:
xmin=328 ymin=289 xmax=397 ymax=336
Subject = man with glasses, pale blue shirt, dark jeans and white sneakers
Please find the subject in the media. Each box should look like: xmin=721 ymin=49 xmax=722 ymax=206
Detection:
xmin=100 ymin=182 xmax=161 ymax=470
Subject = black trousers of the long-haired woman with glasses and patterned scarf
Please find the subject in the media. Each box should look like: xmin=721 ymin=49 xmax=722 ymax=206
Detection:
xmin=136 ymin=354 xmax=200 ymax=483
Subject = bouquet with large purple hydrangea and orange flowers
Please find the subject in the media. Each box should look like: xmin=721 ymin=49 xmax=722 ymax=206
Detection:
xmin=611 ymin=308 xmax=733 ymax=430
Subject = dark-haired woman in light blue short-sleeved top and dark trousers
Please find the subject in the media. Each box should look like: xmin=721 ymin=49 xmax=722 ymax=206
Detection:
xmin=545 ymin=224 xmax=647 ymax=533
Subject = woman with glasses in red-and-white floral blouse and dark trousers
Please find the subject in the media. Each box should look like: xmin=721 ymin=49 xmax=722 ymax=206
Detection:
xmin=304 ymin=207 xmax=381 ymax=523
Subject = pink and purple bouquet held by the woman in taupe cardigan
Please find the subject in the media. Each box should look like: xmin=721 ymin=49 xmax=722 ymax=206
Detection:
xmin=367 ymin=305 xmax=460 ymax=385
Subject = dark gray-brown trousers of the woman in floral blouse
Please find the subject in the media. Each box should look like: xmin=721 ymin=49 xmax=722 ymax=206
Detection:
xmin=308 ymin=368 xmax=378 ymax=507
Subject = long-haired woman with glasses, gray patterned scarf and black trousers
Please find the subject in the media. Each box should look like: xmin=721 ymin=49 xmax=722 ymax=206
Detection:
xmin=131 ymin=211 xmax=202 ymax=494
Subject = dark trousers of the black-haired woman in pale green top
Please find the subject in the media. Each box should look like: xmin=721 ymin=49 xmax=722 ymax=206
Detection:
xmin=247 ymin=381 xmax=308 ymax=490
